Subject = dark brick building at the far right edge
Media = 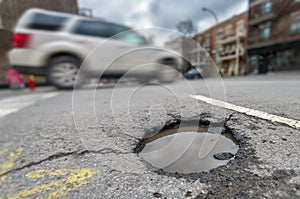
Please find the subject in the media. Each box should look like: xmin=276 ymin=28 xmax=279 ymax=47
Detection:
xmin=248 ymin=0 xmax=300 ymax=73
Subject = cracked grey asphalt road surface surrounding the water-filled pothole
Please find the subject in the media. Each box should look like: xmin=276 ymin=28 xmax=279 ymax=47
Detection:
xmin=0 ymin=73 xmax=300 ymax=198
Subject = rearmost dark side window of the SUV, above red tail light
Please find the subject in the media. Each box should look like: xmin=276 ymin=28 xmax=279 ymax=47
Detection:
xmin=26 ymin=13 xmax=68 ymax=31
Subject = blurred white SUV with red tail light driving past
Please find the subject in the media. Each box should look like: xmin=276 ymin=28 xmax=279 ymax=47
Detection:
xmin=9 ymin=9 xmax=179 ymax=89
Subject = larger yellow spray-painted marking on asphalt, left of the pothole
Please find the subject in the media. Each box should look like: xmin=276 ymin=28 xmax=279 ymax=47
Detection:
xmin=0 ymin=168 xmax=101 ymax=199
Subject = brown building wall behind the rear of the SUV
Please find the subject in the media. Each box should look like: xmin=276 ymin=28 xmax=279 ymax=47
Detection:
xmin=0 ymin=0 xmax=78 ymax=84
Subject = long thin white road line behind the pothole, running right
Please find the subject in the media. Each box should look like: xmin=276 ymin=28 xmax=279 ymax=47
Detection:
xmin=190 ymin=95 xmax=300 ymax=129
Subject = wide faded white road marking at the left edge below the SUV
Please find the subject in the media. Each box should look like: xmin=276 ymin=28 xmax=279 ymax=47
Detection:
xmin=0 ymin=93 xmax=57 ymax=118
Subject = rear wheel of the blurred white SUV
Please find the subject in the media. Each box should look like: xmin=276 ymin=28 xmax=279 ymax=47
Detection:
xmin=48 ymin=56 xmax=80 ymax=89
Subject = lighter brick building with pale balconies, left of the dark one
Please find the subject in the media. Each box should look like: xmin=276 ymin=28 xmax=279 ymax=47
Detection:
xmin=194 ymin=12 xmax=248 ymax=75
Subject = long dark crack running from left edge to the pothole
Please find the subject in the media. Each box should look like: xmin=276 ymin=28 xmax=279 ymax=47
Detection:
xmin=0 ymin=147 xmax=131 ymax=178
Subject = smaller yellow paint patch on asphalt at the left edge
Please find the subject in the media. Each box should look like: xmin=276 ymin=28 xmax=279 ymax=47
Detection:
xmin=0 ymin=148 xmax=23 ymax=186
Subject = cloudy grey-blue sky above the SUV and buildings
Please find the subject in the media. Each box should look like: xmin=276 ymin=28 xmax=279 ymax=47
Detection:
xmin=78 ymin=0 xmax=248 ymax=32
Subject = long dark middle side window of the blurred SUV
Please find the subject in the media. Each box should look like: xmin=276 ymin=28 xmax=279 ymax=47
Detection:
xmin=73 ymin=20 xmax=129 ymax=38
